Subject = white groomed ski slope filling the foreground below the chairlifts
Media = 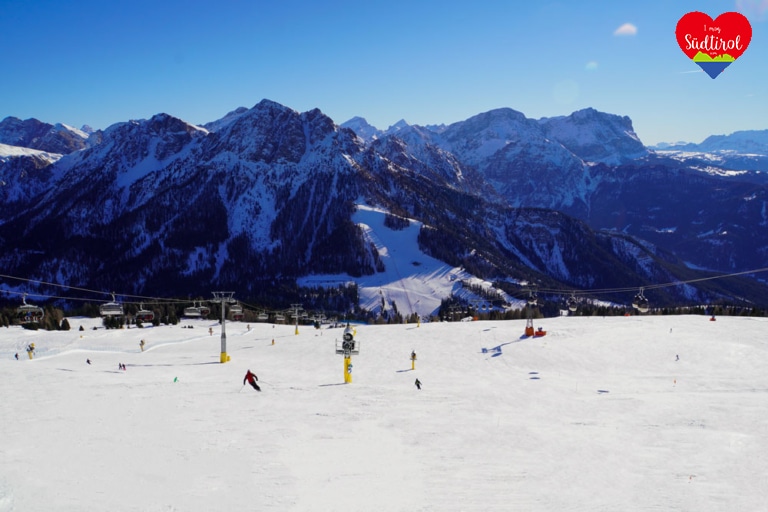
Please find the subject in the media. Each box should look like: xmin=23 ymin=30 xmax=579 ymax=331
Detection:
xmin=0 ymin=316 xmax=768 ymax=512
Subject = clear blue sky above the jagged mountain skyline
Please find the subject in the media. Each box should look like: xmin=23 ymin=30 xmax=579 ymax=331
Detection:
xmin=0 ymin=0 xmax=768 ymax=144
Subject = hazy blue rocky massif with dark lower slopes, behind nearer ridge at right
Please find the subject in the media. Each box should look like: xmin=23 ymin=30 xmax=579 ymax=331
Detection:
xmin=340 ymin=109 xmax=768 ymax=271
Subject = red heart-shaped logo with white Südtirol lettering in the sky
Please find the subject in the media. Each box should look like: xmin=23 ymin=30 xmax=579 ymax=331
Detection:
xmin=675 ymin=11 xmax=752 ymax=78
